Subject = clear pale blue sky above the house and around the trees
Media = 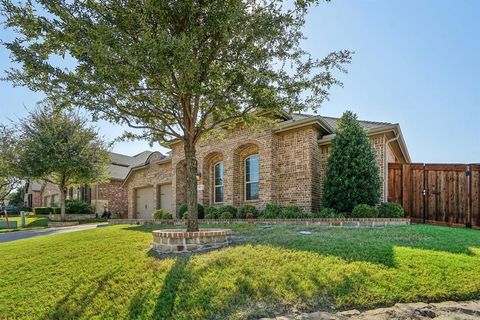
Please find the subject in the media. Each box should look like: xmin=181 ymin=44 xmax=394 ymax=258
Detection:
xmin=0 ymin=0 xmax=480 ymax=163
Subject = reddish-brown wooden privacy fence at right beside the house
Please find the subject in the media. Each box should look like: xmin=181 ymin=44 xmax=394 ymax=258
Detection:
xmin=388 ymin=163 xmax=480 ymax=228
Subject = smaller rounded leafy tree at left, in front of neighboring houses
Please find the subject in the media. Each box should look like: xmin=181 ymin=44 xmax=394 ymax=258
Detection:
xmin=17 ymin=104 xmax=109 ymax=220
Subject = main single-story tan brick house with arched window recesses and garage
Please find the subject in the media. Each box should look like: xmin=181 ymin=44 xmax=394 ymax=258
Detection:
xmin=125 ymin=114 xmax=410 ymax=219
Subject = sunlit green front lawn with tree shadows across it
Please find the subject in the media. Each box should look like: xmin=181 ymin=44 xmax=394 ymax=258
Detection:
xmin=0 ymin=224 xmax=480 ymax=319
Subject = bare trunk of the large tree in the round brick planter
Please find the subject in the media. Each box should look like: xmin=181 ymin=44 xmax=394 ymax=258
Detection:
xmin=184 ymin=142 xmax=198 ymax=232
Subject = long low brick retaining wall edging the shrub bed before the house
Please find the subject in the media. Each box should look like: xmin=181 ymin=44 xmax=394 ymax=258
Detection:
xmin=108 ymin=218 xmax=410 ymax=228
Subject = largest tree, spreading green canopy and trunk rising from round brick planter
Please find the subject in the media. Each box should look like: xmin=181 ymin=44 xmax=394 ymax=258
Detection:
xmin=0 ymin=0 xmax=351 ymax=231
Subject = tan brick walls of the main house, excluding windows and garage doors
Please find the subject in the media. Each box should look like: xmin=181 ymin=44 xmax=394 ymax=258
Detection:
xmin=128 ymin=126 xmax=394 ymax=217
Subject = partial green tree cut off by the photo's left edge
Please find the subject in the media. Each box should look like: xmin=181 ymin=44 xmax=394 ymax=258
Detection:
xmin=0 ymin=125 xmax=21 ymax=204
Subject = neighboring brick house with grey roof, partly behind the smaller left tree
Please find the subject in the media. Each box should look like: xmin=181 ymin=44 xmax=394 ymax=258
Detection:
xmin=26 ymin=151 xmax=152 ymax=215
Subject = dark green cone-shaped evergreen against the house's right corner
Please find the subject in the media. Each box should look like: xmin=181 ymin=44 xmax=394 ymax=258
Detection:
xmin=322 ymin=111 xmax=381 ymax=212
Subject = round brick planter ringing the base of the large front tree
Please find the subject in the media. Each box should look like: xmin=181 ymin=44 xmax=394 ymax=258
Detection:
xmin=152 ymin=229 xmax=232 ymax=253
